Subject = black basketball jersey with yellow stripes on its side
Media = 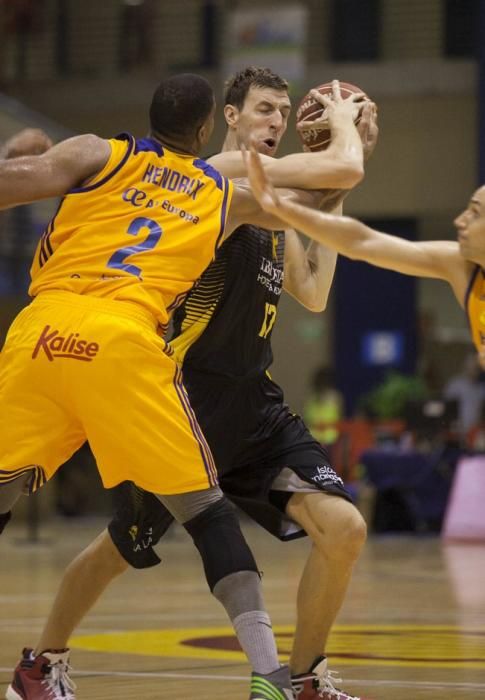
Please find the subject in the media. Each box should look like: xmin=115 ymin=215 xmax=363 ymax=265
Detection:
xmin=170 ymin=225 xmax=285 ymax=378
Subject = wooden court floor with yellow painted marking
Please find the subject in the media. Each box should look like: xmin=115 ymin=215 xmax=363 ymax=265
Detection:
xmin=0 ymin=520 xmax=485 ymax=700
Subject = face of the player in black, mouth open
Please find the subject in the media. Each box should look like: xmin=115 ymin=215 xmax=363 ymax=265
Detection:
xmin=230 ymin=86 xmax=291 ymax=156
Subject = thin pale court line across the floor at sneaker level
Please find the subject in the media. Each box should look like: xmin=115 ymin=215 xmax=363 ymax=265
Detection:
xmin=0 ymin=666 xmax=485 ymax=691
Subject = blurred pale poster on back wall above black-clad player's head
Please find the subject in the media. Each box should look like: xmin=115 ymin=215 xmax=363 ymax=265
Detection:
xmin=224 ymin=5 xmax=307 ymax=89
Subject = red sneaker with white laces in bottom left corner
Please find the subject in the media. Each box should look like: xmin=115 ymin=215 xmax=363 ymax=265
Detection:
xmin=5 ymin=649 xmax=76 ymax=700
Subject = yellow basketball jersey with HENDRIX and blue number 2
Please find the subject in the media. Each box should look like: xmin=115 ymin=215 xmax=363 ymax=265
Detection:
xmin=29 ymin=134 xmax=232 ymax=325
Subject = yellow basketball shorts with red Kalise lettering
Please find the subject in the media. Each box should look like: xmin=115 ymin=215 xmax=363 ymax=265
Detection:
xmin=0 ymin=291 xmax=217 ymax=494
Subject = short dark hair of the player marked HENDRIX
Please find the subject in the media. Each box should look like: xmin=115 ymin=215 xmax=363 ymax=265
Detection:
xmin=150 ymin=73 xmax=215 ymax=139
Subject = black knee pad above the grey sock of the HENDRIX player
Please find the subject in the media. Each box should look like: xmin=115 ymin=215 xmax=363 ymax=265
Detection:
xmin=184 ymin=498 xmax=259 ymax=591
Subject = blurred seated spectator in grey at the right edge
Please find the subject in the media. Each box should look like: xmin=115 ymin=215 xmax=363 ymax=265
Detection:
xmin=444 ymin=353 xmax=485 ymax=437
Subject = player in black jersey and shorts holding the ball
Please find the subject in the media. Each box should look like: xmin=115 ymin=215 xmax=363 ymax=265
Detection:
xmin=8 ymin=69 xmax=376 ymax=700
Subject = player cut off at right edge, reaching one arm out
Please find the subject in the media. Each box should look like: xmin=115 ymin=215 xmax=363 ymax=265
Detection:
xmin=248 ymin=141 xmax=485 ymax=365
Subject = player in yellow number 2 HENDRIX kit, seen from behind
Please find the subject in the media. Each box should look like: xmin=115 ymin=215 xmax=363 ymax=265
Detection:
xmin=0 ymin=75 xmax=362 ymax=700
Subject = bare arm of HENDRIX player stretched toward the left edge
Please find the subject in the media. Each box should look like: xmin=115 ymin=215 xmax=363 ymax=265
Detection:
xmin=0 ymin=134 xmax=111 ymax=209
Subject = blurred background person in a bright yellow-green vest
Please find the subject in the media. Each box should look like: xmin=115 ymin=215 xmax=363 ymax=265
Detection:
xmin=303 ymin=367 xmax=344 ymax=445
